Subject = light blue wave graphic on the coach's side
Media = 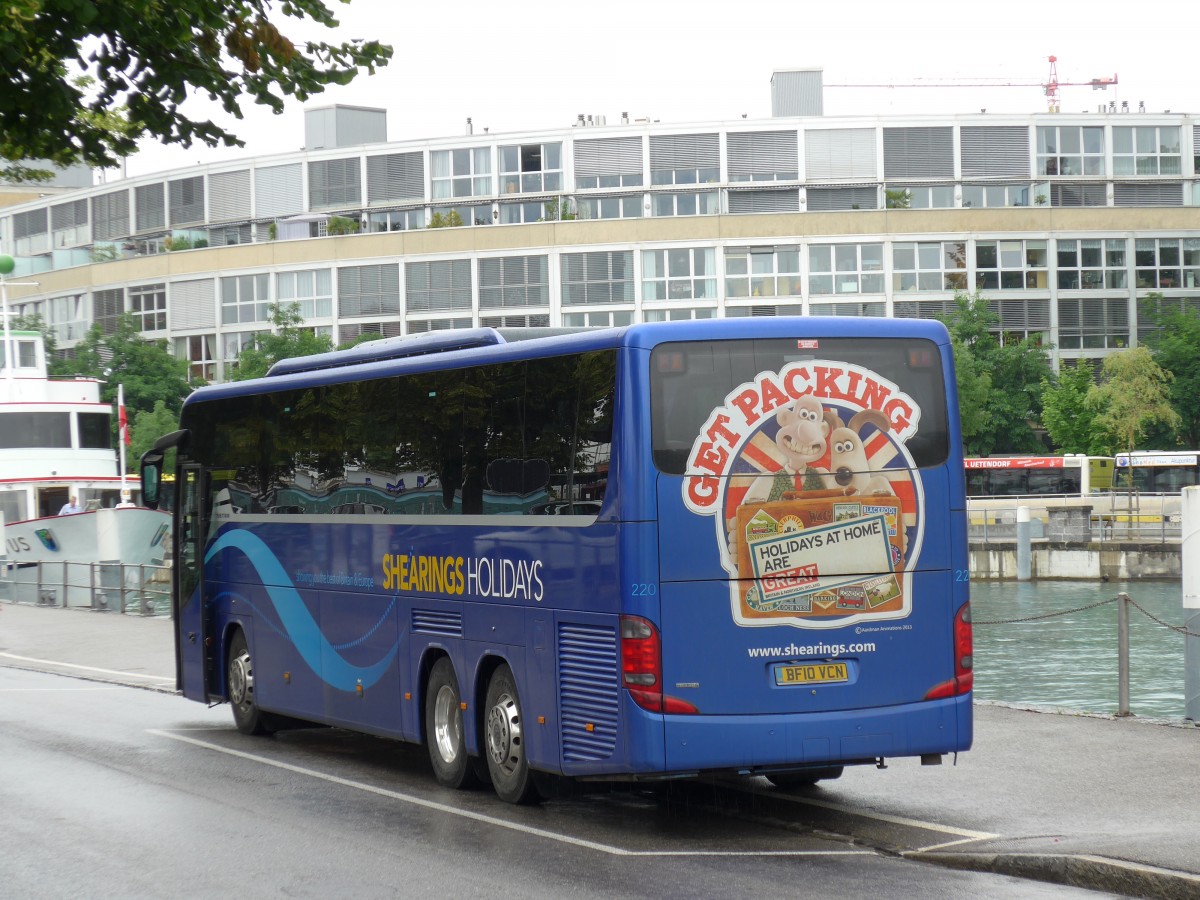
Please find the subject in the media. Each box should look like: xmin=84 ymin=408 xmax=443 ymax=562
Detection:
xmin=204 ymin=530 xmax=400 ymax=691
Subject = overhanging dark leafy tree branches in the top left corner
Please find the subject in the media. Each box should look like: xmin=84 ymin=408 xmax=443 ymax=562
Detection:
xmin=0 ymin=0 xmax=391 ymax=174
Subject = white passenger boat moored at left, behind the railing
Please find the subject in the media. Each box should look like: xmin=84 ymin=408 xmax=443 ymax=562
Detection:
xmin=0 ymin=330 xmax=170 ymax=566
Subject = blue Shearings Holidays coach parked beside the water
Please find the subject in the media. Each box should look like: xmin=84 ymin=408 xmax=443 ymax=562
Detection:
xmin=142 ymin=318 xmax=972 ymax=803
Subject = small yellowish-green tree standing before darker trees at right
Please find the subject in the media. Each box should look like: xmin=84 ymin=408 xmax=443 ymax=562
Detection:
xmin=1087 ymin=347 xmax=1180 ymax=452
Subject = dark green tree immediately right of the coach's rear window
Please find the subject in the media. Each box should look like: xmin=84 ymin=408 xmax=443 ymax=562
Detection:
xmin=946 ymin=292 xmax=1050 ymax=456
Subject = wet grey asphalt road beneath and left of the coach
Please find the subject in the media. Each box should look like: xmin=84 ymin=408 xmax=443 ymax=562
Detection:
xmin=0 ymin=667 xmax=1097 ymax=900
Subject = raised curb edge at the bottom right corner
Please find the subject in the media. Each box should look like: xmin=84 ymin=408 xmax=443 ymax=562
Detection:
xmin=901 ymin=851 xmax=1200 ymax=900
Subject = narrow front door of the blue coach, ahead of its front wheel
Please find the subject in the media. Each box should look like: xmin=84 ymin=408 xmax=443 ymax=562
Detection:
xmin=174 ymin=463 xmax=215 ymax=703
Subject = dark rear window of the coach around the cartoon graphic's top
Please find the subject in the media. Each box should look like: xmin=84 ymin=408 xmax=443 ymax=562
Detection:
xmin=650 ymin=337 xmax=949 ymax=475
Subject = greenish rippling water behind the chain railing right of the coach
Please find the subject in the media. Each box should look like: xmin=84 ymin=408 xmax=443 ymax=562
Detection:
xmin=971 ymin=581 xmax=1184 ymax=719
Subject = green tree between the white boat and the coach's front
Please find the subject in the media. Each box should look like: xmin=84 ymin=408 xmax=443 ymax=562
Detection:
xmin=66 ymin=313 xmax=192 ymax=427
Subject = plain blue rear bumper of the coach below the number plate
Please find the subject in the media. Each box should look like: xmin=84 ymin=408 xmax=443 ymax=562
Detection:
xmin=664 ymin=694 xmax=973 ymax=773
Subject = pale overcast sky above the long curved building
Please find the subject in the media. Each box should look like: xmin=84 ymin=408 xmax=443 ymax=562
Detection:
xmin=119 ymin=0 xmax=1200 ymax=176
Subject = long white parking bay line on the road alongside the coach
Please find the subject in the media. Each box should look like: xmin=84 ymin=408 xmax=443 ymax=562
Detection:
xmin=148 ymin=728 xmax=872 ymax=857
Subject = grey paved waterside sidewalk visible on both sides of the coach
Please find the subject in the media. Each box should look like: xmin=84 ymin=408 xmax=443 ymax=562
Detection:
xmin=0 ymin=604 xmax=1200 ymax=900
